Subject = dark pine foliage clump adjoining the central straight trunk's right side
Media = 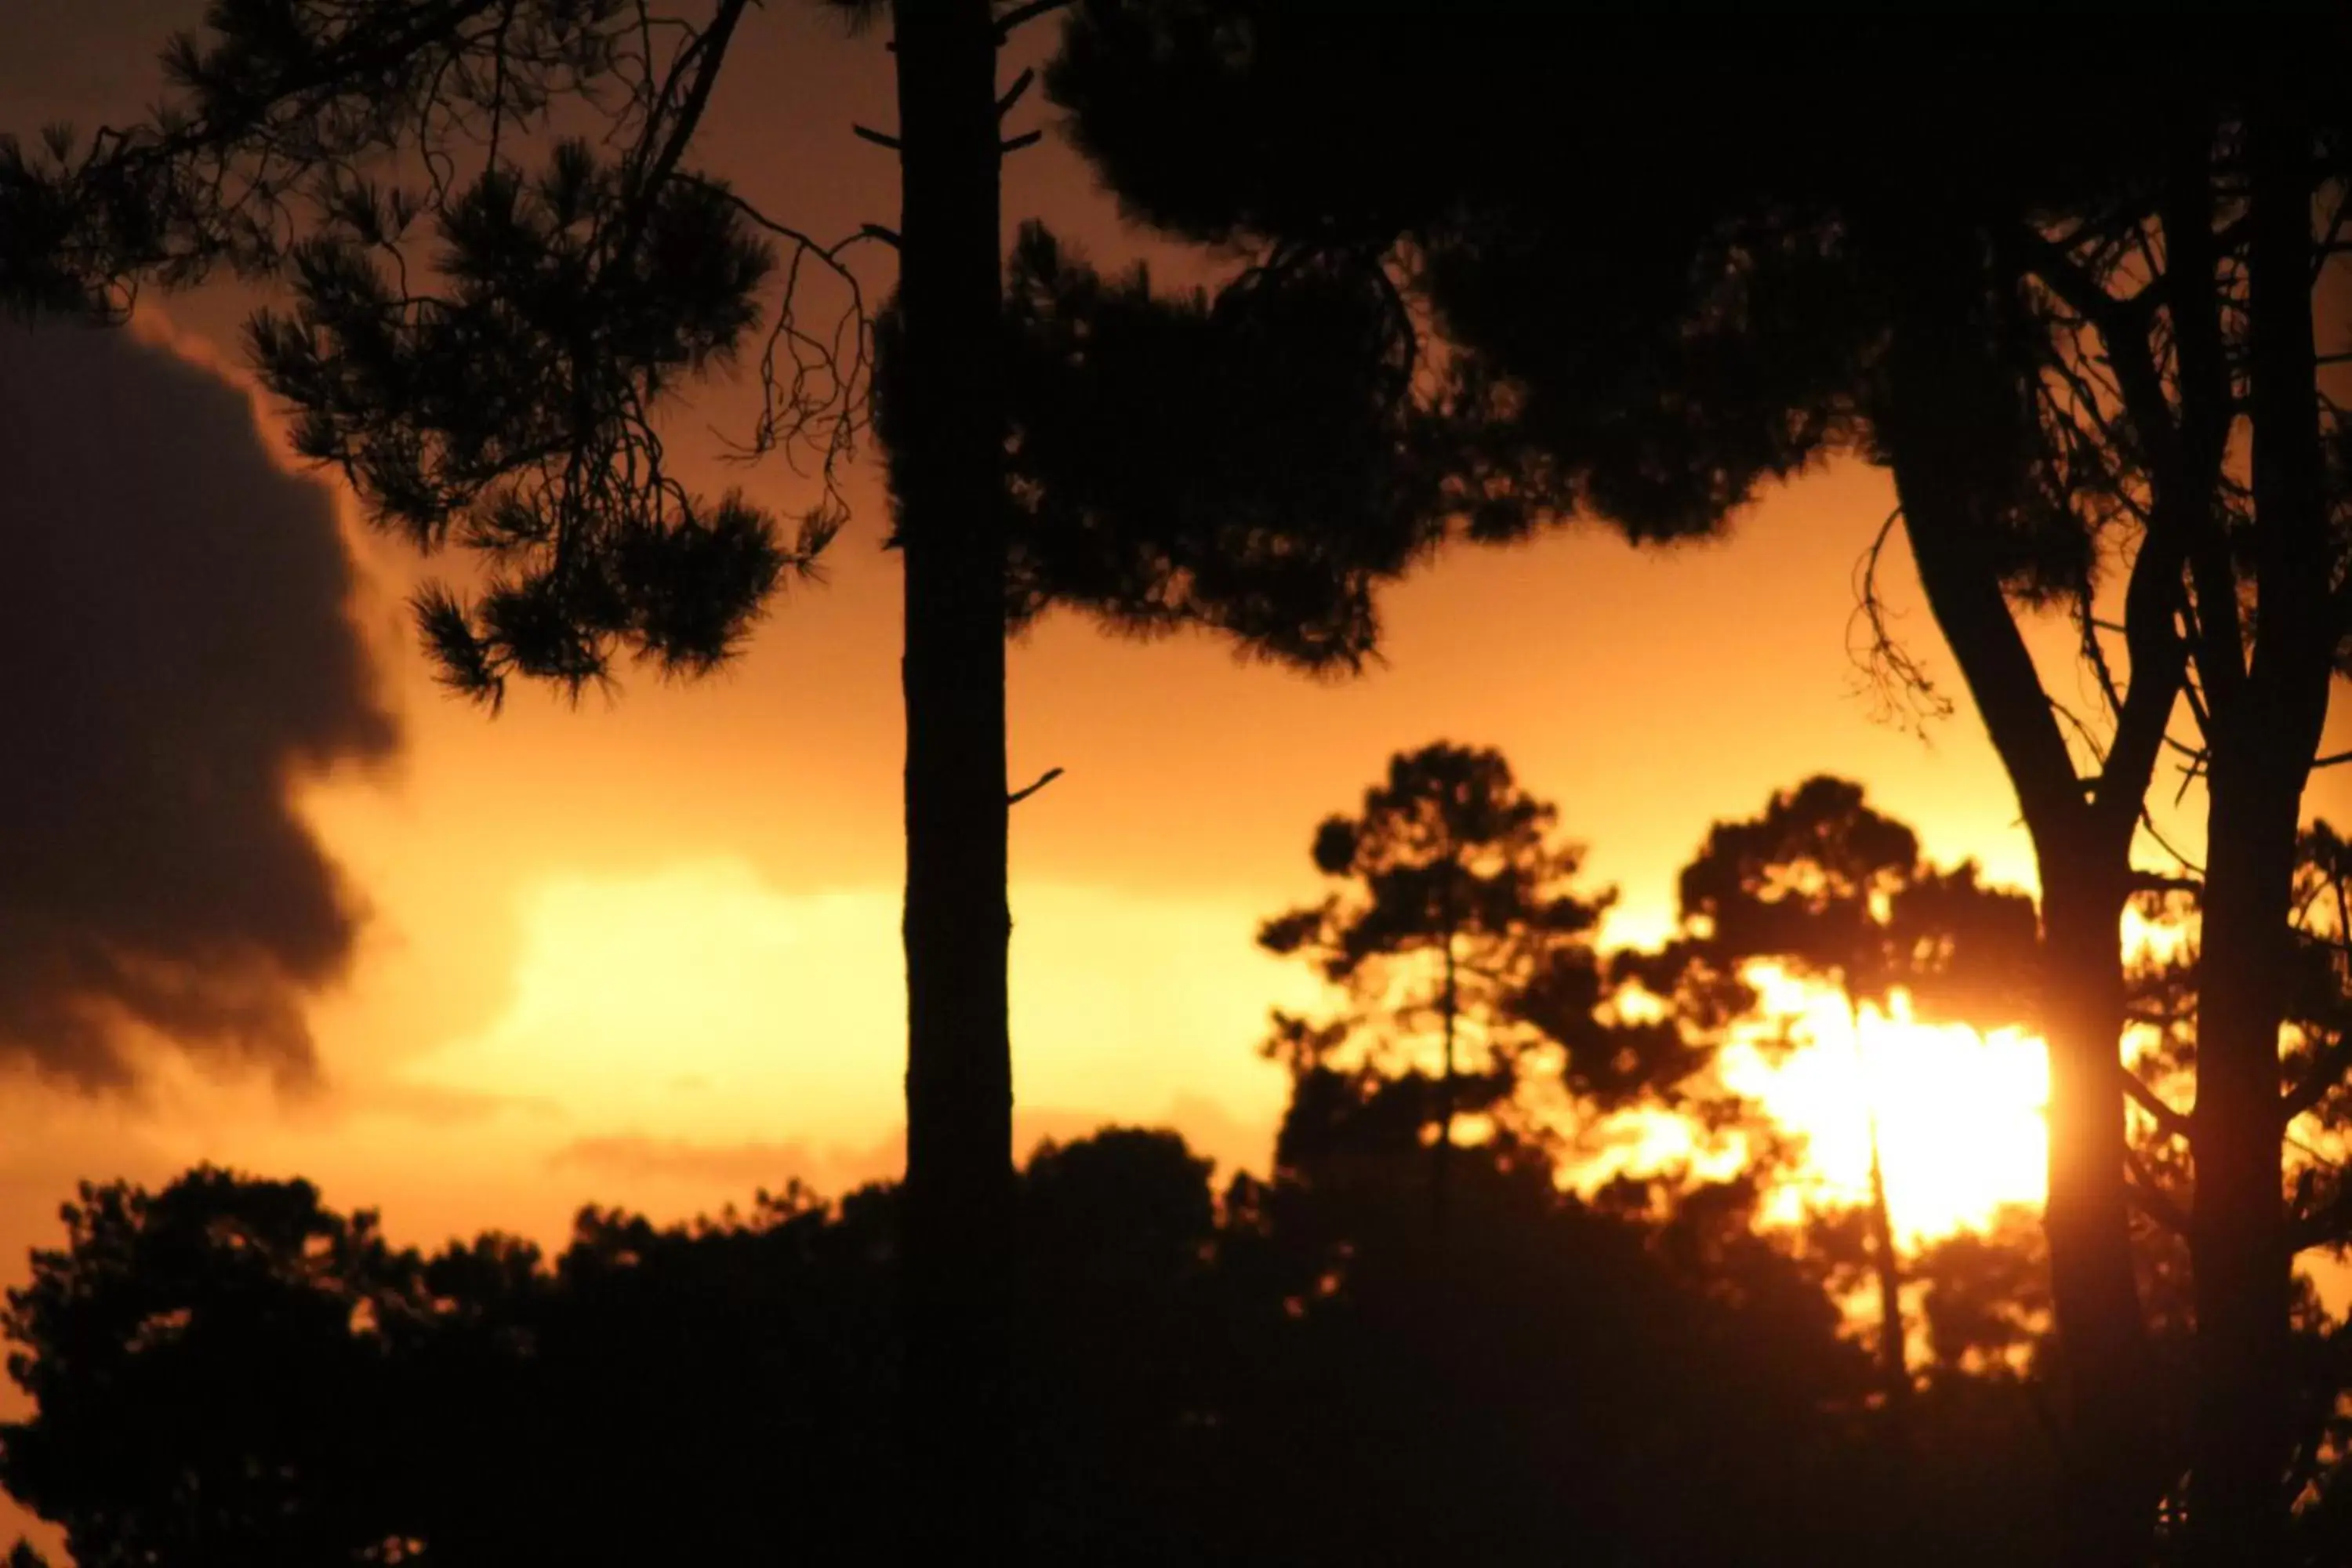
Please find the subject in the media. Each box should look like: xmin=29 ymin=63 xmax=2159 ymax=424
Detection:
xmin=993 ymin=223 xmax=1437 ymax=670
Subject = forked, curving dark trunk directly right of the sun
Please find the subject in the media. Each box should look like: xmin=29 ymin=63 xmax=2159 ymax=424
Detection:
xmin=1870 ymin=214 xmax=2178 ymax=1568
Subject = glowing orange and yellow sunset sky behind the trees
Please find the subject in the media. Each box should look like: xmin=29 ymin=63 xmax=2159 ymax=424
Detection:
xmin=0 ymin=15 xmax=2352 ymax=1523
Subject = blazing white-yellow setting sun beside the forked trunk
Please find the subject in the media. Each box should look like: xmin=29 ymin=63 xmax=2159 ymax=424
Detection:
xmin=1724 ymin=982 xmax=2049 ymax=1246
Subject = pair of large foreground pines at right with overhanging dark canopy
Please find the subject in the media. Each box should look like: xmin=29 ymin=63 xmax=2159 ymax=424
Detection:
xmin=1049 ymin=12 xmax=2347 ymax=1561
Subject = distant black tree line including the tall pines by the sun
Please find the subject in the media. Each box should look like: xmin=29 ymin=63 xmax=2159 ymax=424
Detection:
xmin=0 ymin=761 xmax=2107 ymax=1563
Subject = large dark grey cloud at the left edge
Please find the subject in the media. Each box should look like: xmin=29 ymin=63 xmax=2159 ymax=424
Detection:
xmin=0 ymin=327 xmax=397 ymax=1088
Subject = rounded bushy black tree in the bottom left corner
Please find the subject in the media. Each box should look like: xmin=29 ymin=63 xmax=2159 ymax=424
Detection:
xmin=0 ymin=1166 xmax=421 ymax=1568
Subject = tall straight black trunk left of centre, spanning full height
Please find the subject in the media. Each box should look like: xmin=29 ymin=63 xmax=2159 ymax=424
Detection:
xmin=891 ymin=0 xmax=1018 ymax=1563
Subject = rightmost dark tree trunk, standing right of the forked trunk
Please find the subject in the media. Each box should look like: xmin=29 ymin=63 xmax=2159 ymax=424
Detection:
xmin=2190 ymin=115 xmax=2336 ymax=1568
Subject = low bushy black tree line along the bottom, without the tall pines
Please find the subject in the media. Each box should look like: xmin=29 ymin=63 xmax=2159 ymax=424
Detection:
xmin=0 ymin=1114 xmax=2098 ymax=1566
